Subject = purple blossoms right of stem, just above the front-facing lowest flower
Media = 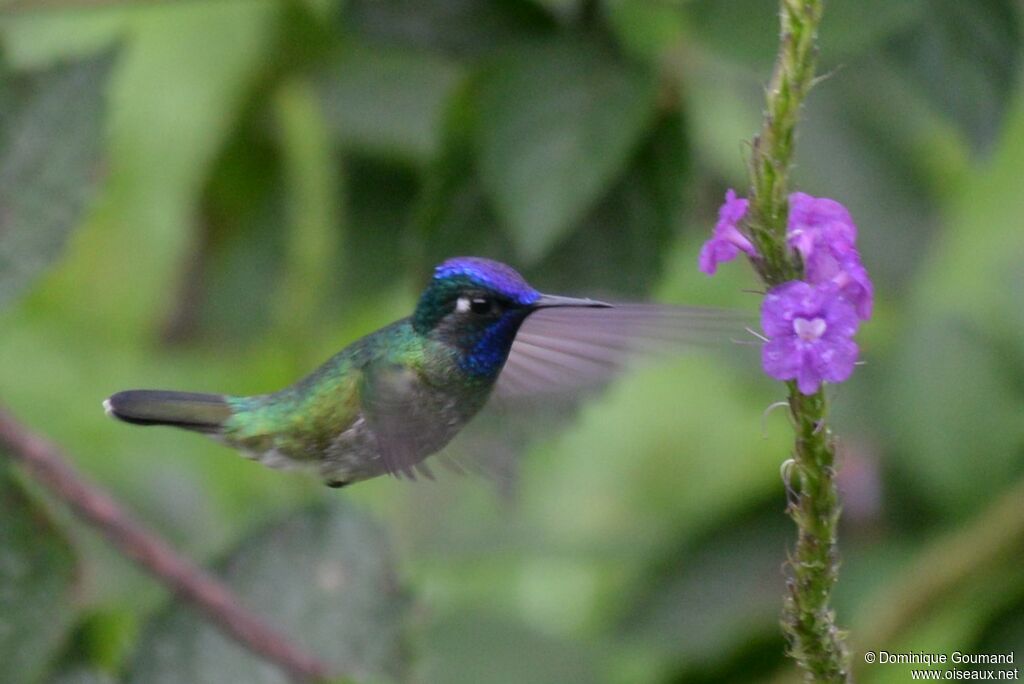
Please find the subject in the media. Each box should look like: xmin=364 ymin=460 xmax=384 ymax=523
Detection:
xmin=786 ymin=193 xmax=874 ymax=320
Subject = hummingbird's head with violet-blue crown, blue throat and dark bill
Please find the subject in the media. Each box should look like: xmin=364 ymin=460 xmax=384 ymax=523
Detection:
xmin=413 ymin=257 xmax=610 ymax=377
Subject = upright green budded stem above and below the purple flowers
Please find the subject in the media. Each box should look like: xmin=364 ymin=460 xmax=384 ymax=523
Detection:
xmin=748 ymin=0 xmax=851 ymax=682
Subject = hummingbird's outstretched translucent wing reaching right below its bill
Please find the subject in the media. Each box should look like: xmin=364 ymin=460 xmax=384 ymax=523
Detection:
xmin=495 ymin=304 xmax=754 ymax=399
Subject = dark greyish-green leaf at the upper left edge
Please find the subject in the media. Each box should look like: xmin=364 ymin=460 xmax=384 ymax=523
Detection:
xmin=0 ymin=53 xmax=114 ymax=305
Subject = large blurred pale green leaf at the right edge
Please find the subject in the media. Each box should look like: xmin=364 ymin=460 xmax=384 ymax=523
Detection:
xmin=880 ymin=103 xmax=1024 ymax=517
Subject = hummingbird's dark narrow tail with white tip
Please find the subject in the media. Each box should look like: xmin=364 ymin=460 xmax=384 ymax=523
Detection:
xmin=103 ymin=389 xmax=231 ymax=433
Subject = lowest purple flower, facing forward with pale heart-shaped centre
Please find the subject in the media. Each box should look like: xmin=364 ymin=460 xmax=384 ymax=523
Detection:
xmin=761 ymin=281 xmax=858 ymax=394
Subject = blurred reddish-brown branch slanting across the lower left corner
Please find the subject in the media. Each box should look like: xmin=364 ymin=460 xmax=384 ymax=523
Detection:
xmin=0 ymin=409 xmax=329 ymax=682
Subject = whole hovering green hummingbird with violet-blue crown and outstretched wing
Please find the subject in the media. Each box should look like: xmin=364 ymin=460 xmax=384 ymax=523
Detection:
xmin=103 ymin=257 xmax=737 ymax=487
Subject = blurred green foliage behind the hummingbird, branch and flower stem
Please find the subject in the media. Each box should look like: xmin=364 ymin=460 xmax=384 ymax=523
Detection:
xmin=0 ymin=0 xmax=1024 ymax=684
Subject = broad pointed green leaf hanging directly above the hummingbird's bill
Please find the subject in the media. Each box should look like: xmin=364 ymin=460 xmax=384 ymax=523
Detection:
xmin=478 ymin=41 xmax=656 ymax=262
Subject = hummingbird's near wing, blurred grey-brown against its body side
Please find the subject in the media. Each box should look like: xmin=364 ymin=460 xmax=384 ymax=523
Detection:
xmin=359 ymin=364 xmax=446 ymax=479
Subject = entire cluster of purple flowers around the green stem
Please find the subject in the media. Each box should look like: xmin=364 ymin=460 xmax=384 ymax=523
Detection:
xmin=700 ymin=189 xmax=874 ymax=394
